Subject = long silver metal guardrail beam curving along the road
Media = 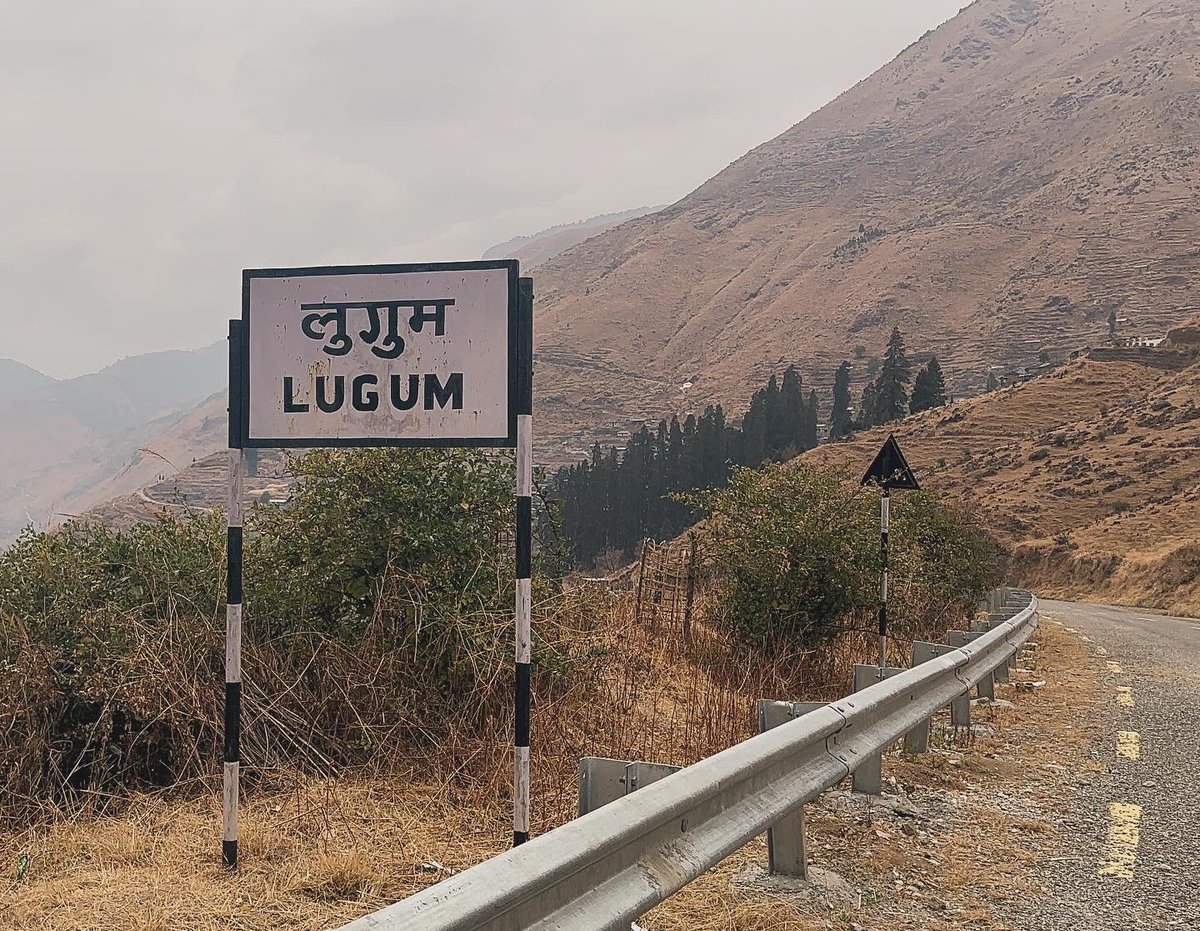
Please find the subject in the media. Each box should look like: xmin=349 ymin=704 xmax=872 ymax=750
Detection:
xmin=343 ymin=589 xmax=1037 ymax=931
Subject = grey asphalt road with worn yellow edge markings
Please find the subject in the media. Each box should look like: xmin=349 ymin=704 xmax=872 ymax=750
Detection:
xmin=1019 ymin=601 xmax=1200 ymax=931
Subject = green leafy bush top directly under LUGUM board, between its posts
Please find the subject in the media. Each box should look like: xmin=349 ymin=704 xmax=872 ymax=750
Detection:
xmin=246 ymin=450 xmax=514 ymax=643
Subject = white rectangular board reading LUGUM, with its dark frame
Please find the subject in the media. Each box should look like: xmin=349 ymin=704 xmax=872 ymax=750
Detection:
xmin=240 ymin=260 xmax=518 ymax=448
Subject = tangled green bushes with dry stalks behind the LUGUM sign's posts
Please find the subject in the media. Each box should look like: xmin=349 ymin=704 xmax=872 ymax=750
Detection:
xmin=0 ymin=450 xmax=565 ymax=812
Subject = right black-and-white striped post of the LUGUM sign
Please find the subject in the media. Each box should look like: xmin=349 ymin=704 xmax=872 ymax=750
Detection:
xmin=512 ymin=278 xmax=533 ymax=847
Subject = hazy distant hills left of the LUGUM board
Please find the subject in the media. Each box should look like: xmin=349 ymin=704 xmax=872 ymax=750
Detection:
xmin=0 ymin=342 xmax=228 ymax=543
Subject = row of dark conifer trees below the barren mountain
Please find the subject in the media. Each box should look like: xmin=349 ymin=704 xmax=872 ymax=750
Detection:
xmin=547 ymin=329 xmax=946 ymax=565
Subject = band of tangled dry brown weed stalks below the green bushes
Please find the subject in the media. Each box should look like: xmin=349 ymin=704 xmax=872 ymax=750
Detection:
xmin=0 ymin=537 xmax=969 ymax=830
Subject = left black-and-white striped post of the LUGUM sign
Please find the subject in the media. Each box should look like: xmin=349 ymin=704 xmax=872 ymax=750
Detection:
xmin=221 ymin=320 xmax=246 ymax=870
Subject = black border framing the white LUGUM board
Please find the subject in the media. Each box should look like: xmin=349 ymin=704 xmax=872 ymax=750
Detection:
xmin=241 ymin=259 xmax=523 ymax=449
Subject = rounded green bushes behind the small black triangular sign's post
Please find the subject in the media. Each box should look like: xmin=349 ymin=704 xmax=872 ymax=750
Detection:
xmin=701 ymin=463 xmax=998 ymax=648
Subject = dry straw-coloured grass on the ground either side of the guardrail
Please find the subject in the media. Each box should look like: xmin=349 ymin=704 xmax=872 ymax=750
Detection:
xmin=0 ymin=600 xmax=1092 ymax=931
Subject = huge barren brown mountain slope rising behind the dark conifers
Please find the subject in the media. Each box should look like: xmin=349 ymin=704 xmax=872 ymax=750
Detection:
xmin=535 ymin=0 xmax=1200 ymax=454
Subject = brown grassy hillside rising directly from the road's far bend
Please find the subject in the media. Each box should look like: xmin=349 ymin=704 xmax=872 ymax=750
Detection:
xmin=805 ymin=333 xmax=1200 ymax=614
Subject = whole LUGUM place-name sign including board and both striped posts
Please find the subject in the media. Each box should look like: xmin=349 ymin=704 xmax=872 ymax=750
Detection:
xmin=222 ymin=259 xmax=533 ymax=869
